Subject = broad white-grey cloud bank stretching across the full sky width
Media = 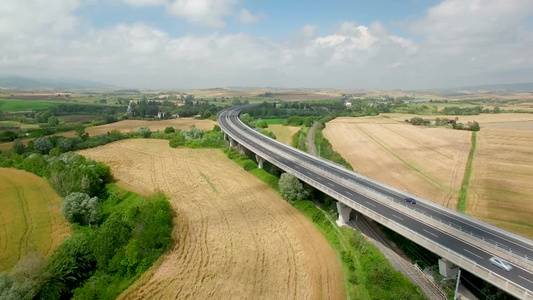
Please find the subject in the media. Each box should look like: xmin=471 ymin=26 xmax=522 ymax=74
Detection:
xmin=0 ymin=0 xmax=533 ymax=88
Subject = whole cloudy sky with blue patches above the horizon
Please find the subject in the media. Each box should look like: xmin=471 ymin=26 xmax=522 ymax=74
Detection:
xmin=0 ymin=0 xmax=533 ymax=89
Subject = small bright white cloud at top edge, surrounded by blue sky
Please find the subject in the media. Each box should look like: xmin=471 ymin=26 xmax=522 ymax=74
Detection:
xmin=167 ymin=0 xmax=237 ymax=27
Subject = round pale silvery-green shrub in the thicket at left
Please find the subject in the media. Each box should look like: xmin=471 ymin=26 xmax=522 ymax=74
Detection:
xmin=61 ymin=193 xmax=99 ymax=225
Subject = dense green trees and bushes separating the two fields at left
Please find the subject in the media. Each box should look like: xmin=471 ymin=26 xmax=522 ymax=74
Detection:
xmin=0 ymin=130 xmax=172 ymax=299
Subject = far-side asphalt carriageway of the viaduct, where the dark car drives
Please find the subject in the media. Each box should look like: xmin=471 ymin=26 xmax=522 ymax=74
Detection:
xmin=223 ymin=108 xmax=533 ymax=260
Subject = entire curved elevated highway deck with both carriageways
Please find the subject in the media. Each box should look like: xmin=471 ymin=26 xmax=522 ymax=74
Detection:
xmin=218 ymin=106 xmax=533 ymax=299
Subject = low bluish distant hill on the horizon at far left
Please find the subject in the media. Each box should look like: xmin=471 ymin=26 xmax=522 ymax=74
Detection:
xmin=0 ymin=76 xmax=113 ymax=90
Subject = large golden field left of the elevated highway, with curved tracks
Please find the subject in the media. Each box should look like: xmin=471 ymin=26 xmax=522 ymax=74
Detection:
xmin=80 ymin=140 xmax=345 ymax=299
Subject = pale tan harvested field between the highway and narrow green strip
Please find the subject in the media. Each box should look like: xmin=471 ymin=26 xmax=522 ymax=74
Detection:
xmin=323 ymin=116 xmax=471 ymax=209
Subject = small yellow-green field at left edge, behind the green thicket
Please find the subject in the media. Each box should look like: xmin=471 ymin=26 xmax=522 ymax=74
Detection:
xmin=0 ymin=168 xmax=70 ymax=271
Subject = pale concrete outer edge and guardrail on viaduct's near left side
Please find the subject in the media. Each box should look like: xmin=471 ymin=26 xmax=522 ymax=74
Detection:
xmin=222 ymin=117 xmax=533 ymax=300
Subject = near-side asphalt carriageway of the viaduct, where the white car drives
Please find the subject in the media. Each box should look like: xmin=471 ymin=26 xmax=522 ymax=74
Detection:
xmin=215 ymin=108 xmax=533 ymax=290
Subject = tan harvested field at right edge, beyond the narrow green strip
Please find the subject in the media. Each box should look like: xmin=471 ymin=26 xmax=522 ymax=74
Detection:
xmin=466 ymin=121 xmax=533 ymax=238
